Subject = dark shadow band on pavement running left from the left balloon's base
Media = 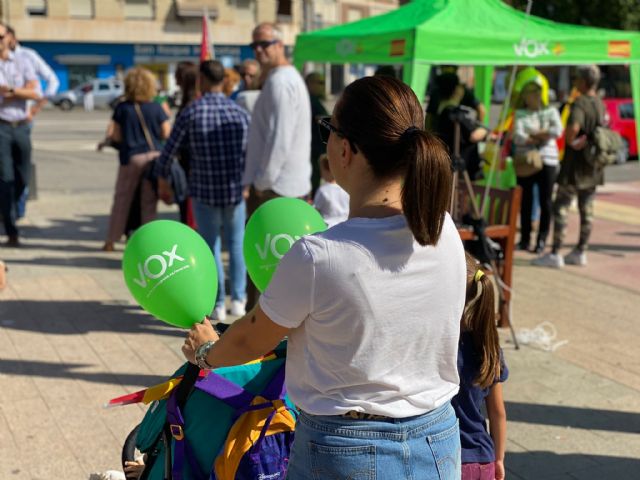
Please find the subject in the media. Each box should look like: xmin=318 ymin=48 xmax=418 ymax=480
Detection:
xmin=0 ymin=300 xmax=185 ymax=337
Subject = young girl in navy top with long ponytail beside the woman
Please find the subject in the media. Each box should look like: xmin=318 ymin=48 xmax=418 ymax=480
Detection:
xmin=451 ymin=253 xmax=509 ymax=480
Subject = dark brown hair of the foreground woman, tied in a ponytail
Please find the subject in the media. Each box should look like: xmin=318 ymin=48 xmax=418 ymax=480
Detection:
xmin=334 ymin=76 xmax=452 ymax=245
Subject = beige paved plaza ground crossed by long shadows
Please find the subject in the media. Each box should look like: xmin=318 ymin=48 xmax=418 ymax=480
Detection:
xmin=0 ymin=112 xmax=640 ymax=480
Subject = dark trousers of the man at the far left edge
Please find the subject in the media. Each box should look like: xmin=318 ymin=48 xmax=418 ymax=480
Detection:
xmin=0 ymin=123 xmax=31 ymax=236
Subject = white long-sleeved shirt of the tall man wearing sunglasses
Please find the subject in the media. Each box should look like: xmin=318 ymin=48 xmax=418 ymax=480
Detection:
xmin=242 ymin=65 xmax=311 ymax=197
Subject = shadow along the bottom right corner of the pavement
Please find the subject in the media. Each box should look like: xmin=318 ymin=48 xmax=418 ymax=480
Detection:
xmin=505 ymin=451 xmax=640 ymax=480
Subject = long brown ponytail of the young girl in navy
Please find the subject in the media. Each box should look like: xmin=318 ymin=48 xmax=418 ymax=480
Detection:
xmin=461 ymin=253 xmax=501 ymax=388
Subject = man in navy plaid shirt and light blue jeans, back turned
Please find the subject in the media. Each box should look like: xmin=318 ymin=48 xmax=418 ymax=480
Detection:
xmin=156 ymin=60 xmax=250 ymax=321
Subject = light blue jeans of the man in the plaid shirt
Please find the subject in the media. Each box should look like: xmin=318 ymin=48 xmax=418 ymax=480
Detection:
xmin=193 ymin=199 xmax=247 ymax=307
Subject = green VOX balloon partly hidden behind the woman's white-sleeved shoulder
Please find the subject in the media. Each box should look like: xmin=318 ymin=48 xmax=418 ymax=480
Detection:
xmin=243 ymin=197 xmax=327 ymax=292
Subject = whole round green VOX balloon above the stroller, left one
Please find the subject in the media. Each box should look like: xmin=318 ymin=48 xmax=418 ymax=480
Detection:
xmin=122 ymin=220 xmax=218 ymax=328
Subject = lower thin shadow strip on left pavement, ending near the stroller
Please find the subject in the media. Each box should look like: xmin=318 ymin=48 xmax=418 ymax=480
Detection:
xmin=0 ymin=359 xmax=170 ymax=386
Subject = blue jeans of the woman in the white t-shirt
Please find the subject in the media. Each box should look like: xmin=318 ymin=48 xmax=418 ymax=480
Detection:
xmin=287 ymin=402 xmax=462 ymax=480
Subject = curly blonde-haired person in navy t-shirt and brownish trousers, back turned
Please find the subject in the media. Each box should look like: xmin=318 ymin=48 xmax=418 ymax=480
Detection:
xmin=102 ymin=67 xmax=171 ymax=252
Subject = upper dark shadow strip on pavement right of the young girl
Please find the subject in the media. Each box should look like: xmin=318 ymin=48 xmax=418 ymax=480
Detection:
xmin=505 ymin=402 xmax=640 ymax=436
